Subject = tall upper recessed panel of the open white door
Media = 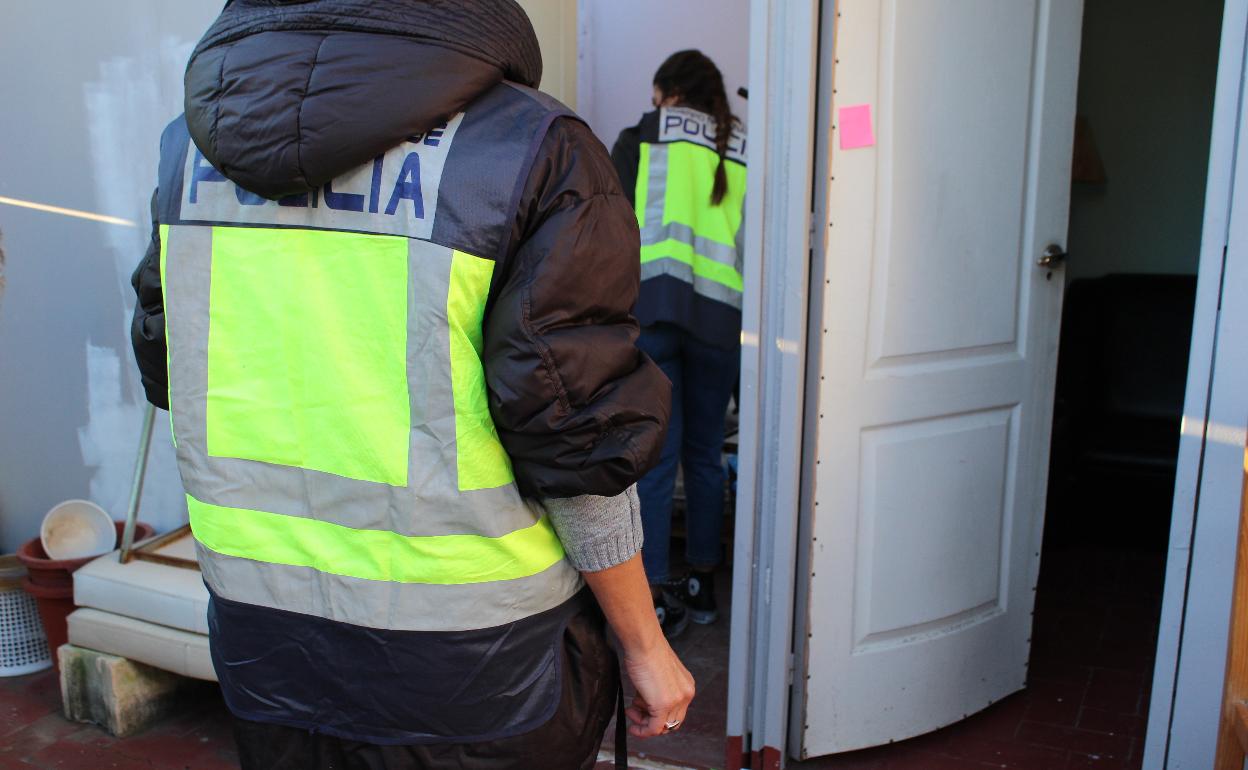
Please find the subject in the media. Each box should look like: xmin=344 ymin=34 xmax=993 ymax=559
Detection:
xmin=870 ymin=0 xmax=1036 ymax=362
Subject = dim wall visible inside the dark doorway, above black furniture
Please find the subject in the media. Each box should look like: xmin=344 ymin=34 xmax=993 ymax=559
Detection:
xmin=1067 ymin=0 xmax=1223 ymax=280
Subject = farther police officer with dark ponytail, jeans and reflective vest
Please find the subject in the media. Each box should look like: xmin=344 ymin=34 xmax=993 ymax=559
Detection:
xmin=612 ymin=50 xmax=745 ymax=638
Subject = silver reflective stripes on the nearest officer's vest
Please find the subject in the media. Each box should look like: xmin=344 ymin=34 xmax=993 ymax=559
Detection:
xmin=165 ymin=226 xmax=580 ymax=630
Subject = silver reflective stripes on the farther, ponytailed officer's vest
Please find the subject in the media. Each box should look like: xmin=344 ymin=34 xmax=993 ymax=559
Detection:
xmin=641 ymin=145 xmax=745 ymax=309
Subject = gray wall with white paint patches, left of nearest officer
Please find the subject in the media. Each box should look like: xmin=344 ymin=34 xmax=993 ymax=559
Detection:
xmin=0 ymin=0 xmax=221 ymax=552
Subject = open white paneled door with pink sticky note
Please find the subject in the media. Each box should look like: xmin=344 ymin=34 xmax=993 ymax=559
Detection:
xmin=795 ymin=0 xmax=1082 ymax=756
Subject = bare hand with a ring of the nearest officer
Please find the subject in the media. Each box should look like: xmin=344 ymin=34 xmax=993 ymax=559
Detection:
xmin=624 ymin=636 xmax=695 ymax=738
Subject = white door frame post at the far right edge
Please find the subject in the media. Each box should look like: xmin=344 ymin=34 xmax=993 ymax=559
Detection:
xmin=1143 ymin=0 xmax=1248 ymax=770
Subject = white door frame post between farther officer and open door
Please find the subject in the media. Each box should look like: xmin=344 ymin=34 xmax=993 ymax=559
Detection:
xmin=726 ymin=0 xmax=820 ymax=770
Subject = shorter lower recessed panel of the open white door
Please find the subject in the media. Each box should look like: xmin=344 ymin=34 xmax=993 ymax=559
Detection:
xmin=854 ymin=408 xmax=1013 ymax=654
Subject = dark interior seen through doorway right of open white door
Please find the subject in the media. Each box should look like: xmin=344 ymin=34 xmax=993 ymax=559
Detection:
xmin=1025 ymin=0 xmax=1224 ymax=768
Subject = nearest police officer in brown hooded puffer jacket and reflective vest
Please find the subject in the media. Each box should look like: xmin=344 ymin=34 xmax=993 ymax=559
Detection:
xmin=134 ymin=0 xmax=693 ymax=770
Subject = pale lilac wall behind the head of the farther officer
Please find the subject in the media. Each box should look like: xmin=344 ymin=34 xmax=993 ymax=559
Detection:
xmin=577 ymin=0 xmax=750 ymax=149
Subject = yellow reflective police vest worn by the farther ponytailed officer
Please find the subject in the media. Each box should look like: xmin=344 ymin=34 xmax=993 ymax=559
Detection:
xmin=634 ymin=107 xmax=745 ymax=348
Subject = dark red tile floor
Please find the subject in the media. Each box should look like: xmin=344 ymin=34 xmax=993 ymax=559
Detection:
xmin=0 ymin=545 xmax=1163 ymax=770
